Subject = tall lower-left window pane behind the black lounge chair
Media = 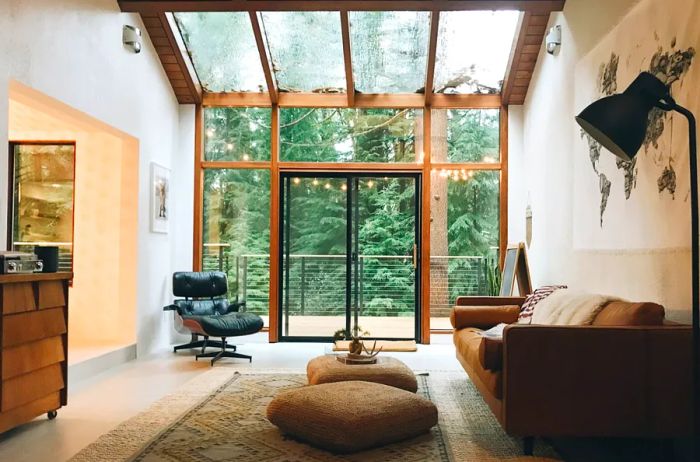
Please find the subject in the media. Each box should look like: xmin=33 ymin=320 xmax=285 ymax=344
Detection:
xmin=202 ymin=169 xmax=270 ymax=325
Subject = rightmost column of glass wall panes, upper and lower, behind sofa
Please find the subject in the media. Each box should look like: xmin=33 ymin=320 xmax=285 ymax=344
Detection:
xmin=430 ymin=109 xmax=500 ymax=329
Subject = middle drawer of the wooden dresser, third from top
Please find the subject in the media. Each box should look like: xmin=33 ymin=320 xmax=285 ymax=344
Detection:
xmin=0 ymin=335 xmax=66 ymax=380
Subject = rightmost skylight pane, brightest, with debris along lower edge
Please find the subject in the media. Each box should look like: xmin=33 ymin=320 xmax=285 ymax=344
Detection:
xmin=433 ymin=11 xmax=520 ymax=93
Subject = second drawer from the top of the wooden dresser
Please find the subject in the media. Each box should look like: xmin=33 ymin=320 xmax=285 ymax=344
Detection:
xmin=2 ymin=308 xmax=66 ymax=348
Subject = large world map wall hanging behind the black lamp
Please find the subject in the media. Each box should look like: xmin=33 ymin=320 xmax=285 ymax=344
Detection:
xmin=572 ymin=0 xmax=700 ymax=249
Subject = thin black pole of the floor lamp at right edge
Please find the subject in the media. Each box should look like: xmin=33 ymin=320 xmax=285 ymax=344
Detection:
xmin=671 ymin=104 xmax=700 ymax=438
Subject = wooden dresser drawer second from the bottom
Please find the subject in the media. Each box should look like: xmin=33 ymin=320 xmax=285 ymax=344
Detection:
xmin=1 ymin=364 xmax=65 ymax=412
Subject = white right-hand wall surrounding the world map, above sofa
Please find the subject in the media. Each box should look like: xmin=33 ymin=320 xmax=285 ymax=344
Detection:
xmin=510 ymin=0 xmax=690 ymax=320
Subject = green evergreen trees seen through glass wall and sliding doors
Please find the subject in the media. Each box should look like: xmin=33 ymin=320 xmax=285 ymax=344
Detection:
xmin=203 ymin=108 xmax=500 ymax=322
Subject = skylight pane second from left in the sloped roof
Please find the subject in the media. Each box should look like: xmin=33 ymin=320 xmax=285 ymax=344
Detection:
xmin=261 ymin=11 xmax=346 ymax=93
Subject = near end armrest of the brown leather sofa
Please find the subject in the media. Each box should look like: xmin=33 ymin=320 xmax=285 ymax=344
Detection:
xmin=503 ymin=325 xmax=692 ymax=437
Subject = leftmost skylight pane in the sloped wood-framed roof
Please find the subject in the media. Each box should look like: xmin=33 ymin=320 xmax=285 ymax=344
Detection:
xmin=174 ymin=12 xmax=267 ymax=92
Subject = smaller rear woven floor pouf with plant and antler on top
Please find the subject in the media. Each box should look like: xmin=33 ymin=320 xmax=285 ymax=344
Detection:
xmin=306 ymin=355 xmax=418 ymax=393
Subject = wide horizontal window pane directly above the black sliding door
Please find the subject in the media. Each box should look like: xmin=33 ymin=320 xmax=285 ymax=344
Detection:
xmin=280 ymin=108 xmax=419 ymax=163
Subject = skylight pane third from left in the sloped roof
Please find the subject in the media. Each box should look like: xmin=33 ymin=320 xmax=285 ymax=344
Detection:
xmin=349 ymin=11 xmax=430 ymax=93
